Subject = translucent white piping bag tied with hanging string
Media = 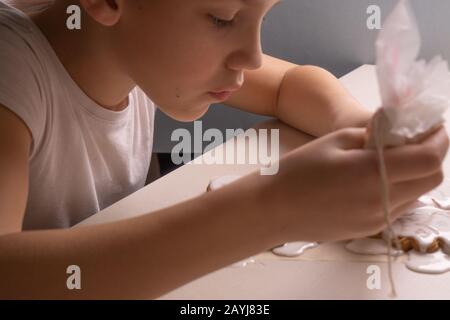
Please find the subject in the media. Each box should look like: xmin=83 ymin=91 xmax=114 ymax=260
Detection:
xmin=365 ymin=0 xmax=450 ymax=297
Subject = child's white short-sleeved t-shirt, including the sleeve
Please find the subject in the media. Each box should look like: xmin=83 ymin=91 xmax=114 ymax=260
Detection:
xmin=0 ymin=2 xmax=155 ymax=230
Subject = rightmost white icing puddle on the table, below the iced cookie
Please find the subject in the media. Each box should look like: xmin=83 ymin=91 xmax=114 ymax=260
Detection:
xmin=406 ymin=250 xmax=450 ymax=274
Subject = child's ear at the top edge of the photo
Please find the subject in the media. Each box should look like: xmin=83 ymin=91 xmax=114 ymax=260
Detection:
xmin=79 ymin=0 xmax=123 ymax=27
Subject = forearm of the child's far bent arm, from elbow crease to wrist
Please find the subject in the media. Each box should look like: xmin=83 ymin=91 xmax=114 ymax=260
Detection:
xmin=277 ymin=66 xmax=373 ymax=137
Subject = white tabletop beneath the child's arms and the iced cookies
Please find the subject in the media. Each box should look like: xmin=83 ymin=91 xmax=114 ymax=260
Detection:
xmin=76 ymin=65 xmax=450 ymax=299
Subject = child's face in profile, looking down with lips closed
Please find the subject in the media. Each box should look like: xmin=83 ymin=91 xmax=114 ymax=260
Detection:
xmin=114 ymin=0 xmax=279 ymax=121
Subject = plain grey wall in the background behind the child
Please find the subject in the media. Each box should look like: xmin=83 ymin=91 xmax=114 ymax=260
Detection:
xmin=154 ymin=0 xmax=450 ymax=152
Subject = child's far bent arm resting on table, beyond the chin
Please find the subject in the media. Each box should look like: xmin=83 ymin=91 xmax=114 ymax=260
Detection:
xmin=225 ymin=55 xmax=373 ymax=137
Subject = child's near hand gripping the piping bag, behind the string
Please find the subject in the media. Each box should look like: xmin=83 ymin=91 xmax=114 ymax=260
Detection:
xmin=261 ymin=127 xmax=449 ymax=243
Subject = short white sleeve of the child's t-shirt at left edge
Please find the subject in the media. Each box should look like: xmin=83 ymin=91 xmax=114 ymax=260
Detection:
xmin=0 ymin=21 xmax=46 ymax=158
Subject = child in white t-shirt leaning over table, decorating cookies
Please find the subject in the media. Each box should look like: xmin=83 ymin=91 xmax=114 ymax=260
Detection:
xmin=0 ymin=0 xmax=448 ymax=298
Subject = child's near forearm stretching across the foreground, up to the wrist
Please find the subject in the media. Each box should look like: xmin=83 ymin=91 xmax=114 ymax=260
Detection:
xmin=0 ymin=174 xmax=277 ymax=299
